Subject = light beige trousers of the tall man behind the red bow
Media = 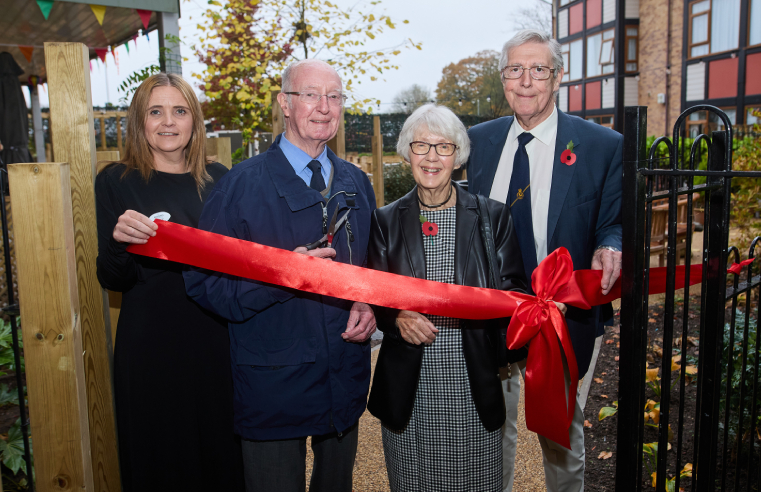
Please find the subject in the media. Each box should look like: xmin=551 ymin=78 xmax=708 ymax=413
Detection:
xmin=500 ymin=360 xmax=586 ymax=492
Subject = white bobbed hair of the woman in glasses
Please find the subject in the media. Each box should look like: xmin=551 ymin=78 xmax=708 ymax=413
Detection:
xmin=396 ymin=104 xmax=470 ymax=168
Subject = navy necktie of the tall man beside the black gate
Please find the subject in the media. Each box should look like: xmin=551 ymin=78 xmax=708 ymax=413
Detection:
xmin=507 ymin=132 xmax=537 ymax=284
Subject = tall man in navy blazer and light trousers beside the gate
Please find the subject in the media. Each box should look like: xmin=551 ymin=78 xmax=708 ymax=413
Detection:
xmin=467 ymin=30 xmax=623 ymax=491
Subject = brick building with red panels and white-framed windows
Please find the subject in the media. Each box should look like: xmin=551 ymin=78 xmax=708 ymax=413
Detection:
xmin=553 ymin=0 xmax=761 ymax=135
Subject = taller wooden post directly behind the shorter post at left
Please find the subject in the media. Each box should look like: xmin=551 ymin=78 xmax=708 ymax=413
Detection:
xmin=45 ymin=43 xmax=121 ymax=492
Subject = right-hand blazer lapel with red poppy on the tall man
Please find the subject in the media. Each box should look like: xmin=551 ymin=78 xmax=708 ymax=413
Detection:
xmin=547 ymin=109 xmax=583 ymax=246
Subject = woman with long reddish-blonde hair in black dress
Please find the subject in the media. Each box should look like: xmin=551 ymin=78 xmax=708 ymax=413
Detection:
xmin=95 ymin=74 xmax=243 ymax=492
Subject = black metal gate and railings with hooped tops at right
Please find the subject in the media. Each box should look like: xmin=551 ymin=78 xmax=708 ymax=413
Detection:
xmin=616 ymin=105 xmax=761 ymax=491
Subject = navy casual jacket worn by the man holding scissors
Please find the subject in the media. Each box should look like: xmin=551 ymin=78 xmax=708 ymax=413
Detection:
xmin=185 ymin=136 xmax=375 ymax=440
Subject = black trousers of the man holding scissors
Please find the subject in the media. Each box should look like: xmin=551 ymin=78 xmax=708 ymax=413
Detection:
xmin=241 ymin=423 xmax=359 ymax=492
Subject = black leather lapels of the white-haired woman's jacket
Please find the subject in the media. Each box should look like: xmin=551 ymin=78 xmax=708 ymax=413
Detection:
xmin=399 ymin=182 xmax=478 ymax=285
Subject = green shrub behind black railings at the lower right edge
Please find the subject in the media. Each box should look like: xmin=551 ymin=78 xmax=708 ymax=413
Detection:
xmin=719 ymin=309 xmax=761 ymax=446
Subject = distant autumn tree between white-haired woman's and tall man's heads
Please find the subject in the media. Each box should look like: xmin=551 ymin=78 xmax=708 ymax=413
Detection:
xmin=436 ymin=50 xmax=511 ymax=118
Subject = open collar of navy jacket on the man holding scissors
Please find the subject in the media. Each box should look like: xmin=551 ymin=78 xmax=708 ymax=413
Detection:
xmin=265 ymin=134 xmax=358 ymax=212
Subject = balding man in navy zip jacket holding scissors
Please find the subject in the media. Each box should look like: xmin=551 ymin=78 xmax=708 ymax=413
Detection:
xmin=185 ymin=60 xmax=375 ymax=492
